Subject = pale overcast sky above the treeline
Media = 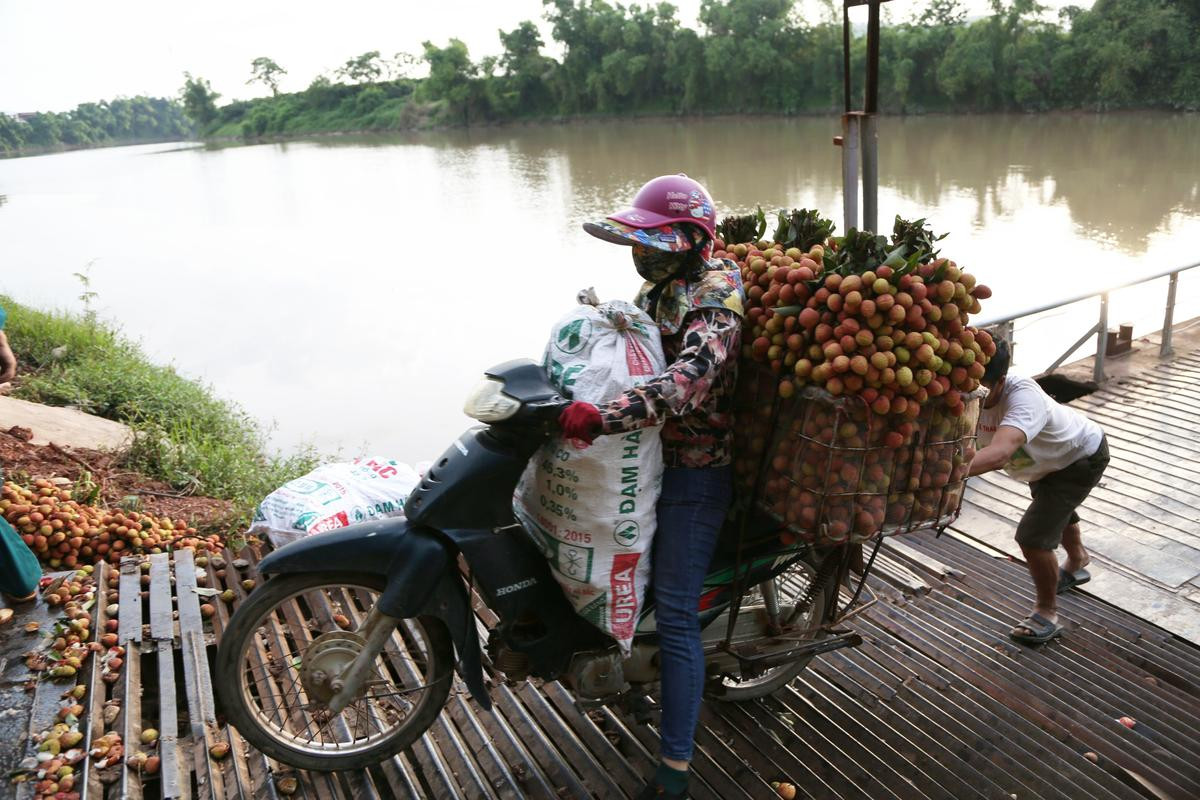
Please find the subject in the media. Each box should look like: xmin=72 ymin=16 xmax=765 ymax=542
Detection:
xmin=0 ymin=0 xmax=1091 ymax=113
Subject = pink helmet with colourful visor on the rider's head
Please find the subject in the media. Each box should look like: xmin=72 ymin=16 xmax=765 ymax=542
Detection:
xmin=583 ymin=173 xmax=716 ymax=252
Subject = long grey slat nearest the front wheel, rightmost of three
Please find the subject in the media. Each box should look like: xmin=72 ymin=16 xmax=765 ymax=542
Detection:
xmin=175 ymin=549 xmax=227 ymax=800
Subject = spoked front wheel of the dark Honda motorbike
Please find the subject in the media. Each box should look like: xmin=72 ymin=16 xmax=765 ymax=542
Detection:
xmin=215 ymin=573 xmax=454 ymax=771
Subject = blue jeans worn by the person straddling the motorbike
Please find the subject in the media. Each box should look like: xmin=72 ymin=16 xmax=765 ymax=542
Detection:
xmin=653 ymin=467 xmax=733 ymax=760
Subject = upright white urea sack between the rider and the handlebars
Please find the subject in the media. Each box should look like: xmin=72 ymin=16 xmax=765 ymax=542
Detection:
xmin=515 ymin=301 xmax=666 ymax=654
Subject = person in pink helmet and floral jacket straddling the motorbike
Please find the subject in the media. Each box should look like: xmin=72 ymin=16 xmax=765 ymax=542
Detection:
xmin=559 ymin=174 xmax=745 ymax=800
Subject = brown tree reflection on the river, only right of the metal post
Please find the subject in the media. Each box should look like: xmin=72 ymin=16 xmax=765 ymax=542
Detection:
xmin=880 ymin=114 xmax=1200 ymax=244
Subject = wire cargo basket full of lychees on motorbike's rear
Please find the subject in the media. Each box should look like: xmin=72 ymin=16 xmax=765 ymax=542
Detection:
xmin=734 ymin=361 xmax=984 ymax=545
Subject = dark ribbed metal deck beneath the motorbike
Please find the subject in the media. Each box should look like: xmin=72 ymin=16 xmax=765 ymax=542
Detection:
xmin=84 ymin=533 xmax=1200 ymax=800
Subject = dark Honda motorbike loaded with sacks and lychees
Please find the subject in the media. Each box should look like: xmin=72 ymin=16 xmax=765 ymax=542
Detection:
xmin=215 ymin=361 xmax=859 ymax=771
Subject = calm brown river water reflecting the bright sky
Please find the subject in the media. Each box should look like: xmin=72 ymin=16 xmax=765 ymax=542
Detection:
xmin=0 ymin=114 xmax=1200 ymax=461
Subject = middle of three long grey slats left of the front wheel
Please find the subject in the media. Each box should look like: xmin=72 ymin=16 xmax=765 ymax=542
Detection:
xmin=150 ymin=553 xmax=191 ymax=800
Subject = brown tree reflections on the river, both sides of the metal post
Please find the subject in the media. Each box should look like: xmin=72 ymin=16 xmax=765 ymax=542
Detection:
xmin=319 ymin=113 xmax=1200 ymax=251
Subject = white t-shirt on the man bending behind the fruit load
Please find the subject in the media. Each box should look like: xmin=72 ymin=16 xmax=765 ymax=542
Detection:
xmin=979 ymin=375 xmax=1104 ymax=483
